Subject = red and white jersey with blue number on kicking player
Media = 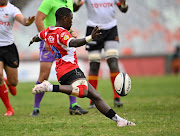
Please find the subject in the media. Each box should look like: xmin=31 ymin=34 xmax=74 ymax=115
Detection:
xmin=39 ymin=26 xmax=79 ymax=80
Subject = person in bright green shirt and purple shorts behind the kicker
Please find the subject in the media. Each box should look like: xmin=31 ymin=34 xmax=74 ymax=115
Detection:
xmin=30 ymin=0 xmax=88 ymax=117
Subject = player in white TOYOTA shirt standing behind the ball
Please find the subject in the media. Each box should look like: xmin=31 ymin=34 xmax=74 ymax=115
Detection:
xmin=74 ymin=0 xmax=128 ymax=108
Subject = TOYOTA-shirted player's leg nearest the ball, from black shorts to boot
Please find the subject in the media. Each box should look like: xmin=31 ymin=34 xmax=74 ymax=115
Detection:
xmin=104 ymin=27 xmax=123 ymax=107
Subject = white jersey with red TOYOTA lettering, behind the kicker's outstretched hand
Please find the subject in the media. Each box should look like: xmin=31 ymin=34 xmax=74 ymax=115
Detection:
xmin=82 ymin=0 xmax=120 ymax=30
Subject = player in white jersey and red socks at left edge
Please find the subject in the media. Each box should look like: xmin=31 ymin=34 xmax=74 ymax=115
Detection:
xmin=0 ymin=0 xmax=35 ymax=116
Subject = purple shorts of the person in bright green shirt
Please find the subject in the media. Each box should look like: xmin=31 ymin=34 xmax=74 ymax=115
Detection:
xmin=39 ymin=41 xmax=55 ymax=62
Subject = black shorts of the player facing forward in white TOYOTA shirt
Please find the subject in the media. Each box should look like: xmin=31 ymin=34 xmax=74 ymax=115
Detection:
xmin=86 ymin=26 xmax=119 ymax=51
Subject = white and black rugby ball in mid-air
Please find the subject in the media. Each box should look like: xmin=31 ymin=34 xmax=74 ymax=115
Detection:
xmin=114 ymin=72 xmax=131 ymax=96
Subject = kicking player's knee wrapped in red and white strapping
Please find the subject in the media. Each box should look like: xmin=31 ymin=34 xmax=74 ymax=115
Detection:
xmin=71 ymin=80 xmax=88 ymax=98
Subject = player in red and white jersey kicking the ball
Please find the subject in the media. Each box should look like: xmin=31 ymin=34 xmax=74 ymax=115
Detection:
xmin=29 ymin=7 xmax=135 ymax=127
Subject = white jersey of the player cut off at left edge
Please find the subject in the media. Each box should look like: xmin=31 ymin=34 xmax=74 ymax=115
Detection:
xmin=0 ymin=2 xmax=21 ymax=47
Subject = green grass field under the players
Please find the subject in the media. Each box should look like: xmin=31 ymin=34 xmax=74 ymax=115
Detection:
xmin=0 ymin=76 xmax=180 ymax=136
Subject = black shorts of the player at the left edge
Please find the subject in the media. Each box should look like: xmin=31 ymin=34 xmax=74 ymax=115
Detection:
xmin=0 ymin=43 xmax=19 ymax=68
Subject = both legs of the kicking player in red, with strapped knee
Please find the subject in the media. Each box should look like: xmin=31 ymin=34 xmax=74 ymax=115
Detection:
xmin=33 ymin=78 xmax=135 ymax=127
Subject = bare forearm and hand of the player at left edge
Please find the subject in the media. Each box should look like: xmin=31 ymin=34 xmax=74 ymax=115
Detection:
xmin=15 ymin=14 xmax=35 ymax=26
